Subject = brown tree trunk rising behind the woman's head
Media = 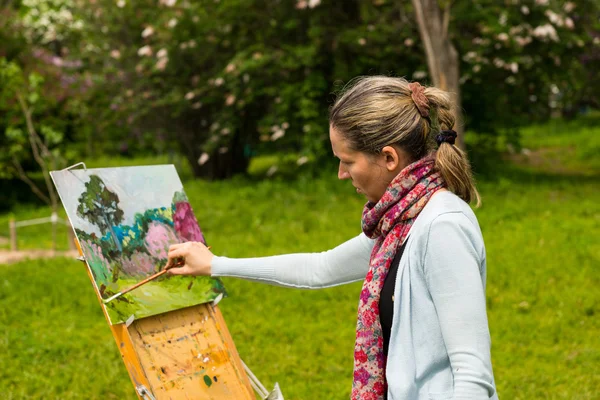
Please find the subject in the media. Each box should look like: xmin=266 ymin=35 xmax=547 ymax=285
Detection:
xmin=412 ymin=0 xmax=465 ymax=150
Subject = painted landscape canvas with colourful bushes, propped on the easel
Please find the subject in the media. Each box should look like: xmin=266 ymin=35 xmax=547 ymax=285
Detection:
xmin=51 ymin=165 xmax=224 ymax=324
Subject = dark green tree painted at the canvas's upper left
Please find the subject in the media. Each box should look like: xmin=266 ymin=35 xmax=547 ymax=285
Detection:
xmin=77 ymin=175 xmax=123 ymax=252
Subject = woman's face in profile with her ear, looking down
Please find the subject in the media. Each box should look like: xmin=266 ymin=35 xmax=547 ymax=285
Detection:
xmin=329 ymin=127 xmax=409 ymax=203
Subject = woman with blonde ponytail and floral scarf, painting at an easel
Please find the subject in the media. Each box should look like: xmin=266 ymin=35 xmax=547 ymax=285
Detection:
xmin=169 ymin=77 xmax=497 ymax=400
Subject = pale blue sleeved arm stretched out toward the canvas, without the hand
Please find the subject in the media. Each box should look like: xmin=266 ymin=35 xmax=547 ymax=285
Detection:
xmin=211 ymin=233 xmax=373 ymax=289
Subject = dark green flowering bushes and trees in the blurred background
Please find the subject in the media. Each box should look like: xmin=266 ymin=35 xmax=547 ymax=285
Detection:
xmin=0 ymin=0 xmax=600 ymax=178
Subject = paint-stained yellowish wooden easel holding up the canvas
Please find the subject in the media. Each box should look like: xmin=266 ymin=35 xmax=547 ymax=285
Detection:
xmin=76 ymin=242 xmax=256 ymax=400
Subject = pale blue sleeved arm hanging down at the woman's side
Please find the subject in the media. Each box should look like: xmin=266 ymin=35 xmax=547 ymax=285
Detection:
xmin=424 ymin=212 xmax=495 ymax=399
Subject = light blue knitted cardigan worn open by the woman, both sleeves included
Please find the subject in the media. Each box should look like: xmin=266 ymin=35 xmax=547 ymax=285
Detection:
xmin=212 ymin=191 xmax=498 ymax=400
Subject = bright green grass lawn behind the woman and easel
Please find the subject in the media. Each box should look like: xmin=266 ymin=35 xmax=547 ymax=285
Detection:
xmin=0 ymin=117 xmax=600 ymax=400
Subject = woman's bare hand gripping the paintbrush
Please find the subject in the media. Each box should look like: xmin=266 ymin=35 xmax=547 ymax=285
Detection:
xmin=166 ymin=242 xmax=214 ymax=276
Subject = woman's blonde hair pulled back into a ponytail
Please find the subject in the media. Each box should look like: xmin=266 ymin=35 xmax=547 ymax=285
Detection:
xmin=329 ymin=76 xmax=481 ymax=206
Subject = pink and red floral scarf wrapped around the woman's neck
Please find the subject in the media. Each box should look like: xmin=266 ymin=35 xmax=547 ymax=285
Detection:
xmin=352 ymin=157 xmax=445 ymax=400
